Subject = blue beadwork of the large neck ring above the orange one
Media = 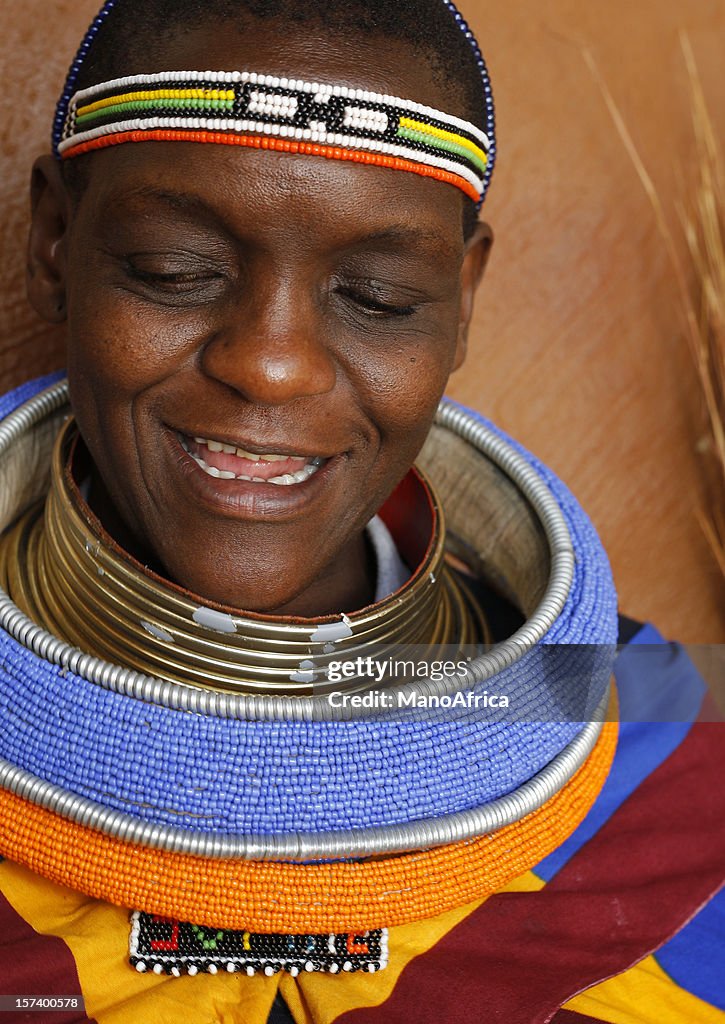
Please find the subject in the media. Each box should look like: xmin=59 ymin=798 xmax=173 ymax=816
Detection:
xmin=0 ymin=380 xmax=616 ymax=835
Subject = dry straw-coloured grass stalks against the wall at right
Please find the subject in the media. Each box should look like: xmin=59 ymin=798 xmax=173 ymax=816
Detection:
xmin=583 ymin=33 xmax=725 ymax=577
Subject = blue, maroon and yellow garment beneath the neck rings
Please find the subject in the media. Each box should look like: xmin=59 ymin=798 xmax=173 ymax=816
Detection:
xmin=0 ymin=621 xmax=725 ymax=1024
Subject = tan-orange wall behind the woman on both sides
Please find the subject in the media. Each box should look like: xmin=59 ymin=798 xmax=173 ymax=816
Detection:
xmin=0 ymin=0 xmax=725 ymax=642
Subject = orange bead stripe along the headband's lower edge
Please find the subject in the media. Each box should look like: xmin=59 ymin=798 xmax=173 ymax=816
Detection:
xmin=62 ymin=129 xmax=479 ymax=203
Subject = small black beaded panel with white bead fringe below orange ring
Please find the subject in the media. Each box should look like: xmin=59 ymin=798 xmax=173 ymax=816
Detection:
xmin=129 ymin=910 xmax=388 ymax=978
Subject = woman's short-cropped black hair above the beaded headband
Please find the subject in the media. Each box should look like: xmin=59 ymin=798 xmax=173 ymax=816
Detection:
xmin=63 ymin=0 xmax=486 ymax=238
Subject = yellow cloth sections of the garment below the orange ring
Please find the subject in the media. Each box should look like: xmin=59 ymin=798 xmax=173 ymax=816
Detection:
xmin=0 ymin=861 xmax=725 ymax=1024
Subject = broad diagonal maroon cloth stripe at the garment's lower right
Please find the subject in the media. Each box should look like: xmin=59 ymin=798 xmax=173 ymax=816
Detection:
xmin=337 ymin=723 xmax=725 ymax=1024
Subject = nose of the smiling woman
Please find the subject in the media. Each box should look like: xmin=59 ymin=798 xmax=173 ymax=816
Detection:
xmin=202 ymin=286 xmax=337 ymax=406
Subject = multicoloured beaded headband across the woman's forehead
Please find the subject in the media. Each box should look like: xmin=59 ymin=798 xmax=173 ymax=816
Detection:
xmin=58 ymin=71 xmax=491 ymax=203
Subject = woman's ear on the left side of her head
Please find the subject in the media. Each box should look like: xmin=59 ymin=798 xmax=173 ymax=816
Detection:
xmin=27 ymin=156 xmax=71 ymax=324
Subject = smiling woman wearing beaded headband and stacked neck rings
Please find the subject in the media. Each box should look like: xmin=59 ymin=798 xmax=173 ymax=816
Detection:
xmin=2 ymin=0 xmax=721 ymax=1021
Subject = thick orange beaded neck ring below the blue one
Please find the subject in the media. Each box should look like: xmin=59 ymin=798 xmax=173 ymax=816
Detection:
xmin=0 ymin=722 xmax=617 ymax=934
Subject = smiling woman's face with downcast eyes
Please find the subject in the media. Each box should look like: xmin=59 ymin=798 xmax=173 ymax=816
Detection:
xmin=31 ymin=29 xmax=487 ymax=614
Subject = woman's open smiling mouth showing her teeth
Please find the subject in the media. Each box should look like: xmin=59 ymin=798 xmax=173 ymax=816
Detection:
xmin=178 ymin=433 xmax=327 ymax=486
